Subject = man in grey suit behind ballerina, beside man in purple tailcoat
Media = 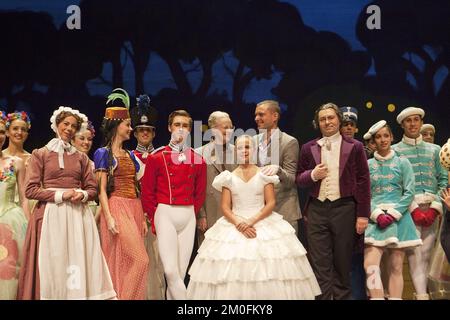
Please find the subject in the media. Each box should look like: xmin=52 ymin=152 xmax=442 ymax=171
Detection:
xmin=255 ymin=100 xmax=301 ymax=235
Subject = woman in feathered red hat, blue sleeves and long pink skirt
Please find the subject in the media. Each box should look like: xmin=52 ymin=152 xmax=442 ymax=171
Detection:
xmin=94 ymin=89 xmax=149 ymax=300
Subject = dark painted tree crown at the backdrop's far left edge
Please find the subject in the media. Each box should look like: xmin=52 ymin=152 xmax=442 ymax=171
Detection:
xmin=0 ymin=11 xmax=57 ymax=111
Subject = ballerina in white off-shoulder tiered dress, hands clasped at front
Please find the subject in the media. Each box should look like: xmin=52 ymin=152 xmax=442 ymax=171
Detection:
xmin=187 ymin=136 xmax=321 ymax=300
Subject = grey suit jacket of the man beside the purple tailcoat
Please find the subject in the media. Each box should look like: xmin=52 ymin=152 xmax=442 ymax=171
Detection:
xmin=255 ymin=130 xmax=301 ymax=222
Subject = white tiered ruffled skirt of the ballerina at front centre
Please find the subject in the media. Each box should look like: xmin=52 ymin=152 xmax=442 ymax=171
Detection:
xmin=187 ymin=213 xmax=321 ymax=300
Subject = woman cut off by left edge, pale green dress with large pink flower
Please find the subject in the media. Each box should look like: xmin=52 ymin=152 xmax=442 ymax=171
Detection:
xmin=0 ymin=111 xmax=27 ymax=300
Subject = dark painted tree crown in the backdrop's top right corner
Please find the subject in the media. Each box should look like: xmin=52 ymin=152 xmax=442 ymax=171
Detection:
xmin=357 ymin=0 xmax=450 ymax=111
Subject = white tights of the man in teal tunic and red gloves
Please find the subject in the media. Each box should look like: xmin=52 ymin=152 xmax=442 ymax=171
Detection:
xmin=406 ymin=219 xmax=438 ymax=295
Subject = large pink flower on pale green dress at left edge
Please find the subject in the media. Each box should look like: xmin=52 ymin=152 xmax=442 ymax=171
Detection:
xmin=0 ymin=223 xmax=19 ymax=280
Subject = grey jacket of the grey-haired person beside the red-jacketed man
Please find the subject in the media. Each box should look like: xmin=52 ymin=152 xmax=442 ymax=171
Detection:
xmin=195 ymin=142 xmax=237 ymax=228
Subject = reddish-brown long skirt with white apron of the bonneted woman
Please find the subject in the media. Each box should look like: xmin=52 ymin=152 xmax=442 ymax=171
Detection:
xmin=19 ymin=198 xmax=116 ymax=300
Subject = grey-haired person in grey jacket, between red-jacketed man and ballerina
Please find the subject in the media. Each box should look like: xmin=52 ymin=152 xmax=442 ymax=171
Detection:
xmin=195 ymin=111 xmax=236 ymax=246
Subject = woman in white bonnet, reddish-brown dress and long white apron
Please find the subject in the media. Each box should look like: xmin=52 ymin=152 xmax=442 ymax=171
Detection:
xmin=18 ymin=107 xmax=116 ymax=300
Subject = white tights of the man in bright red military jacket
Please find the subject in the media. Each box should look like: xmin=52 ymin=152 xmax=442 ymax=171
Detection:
xmin=155 ymin=203 xmax=196 ymax=300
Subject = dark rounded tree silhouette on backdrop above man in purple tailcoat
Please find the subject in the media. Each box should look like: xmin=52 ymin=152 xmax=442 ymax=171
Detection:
xmin=273 ymin=28 xmax=370 ymax=129
